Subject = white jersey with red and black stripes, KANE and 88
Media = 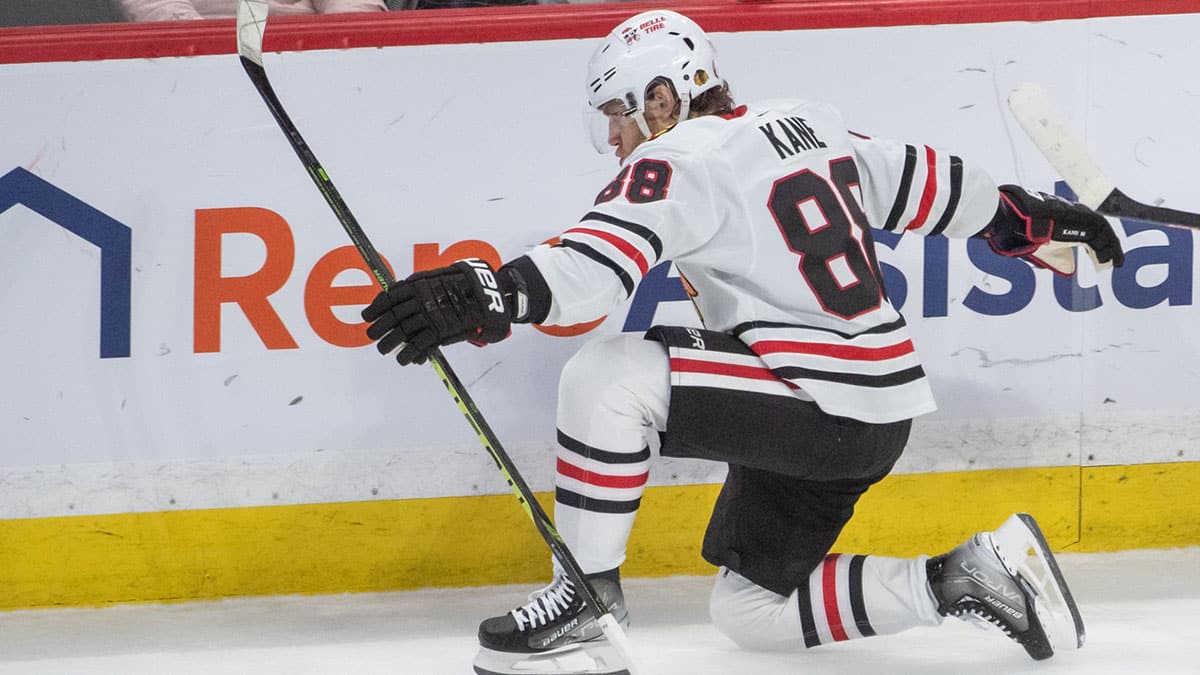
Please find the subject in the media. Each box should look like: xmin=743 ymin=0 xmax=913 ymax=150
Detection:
xmin=529 ymin=101 xmax=997 ymax=423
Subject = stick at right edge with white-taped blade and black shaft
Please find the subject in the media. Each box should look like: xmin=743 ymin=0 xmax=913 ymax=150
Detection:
xmin=1008 ymin=83 xmax=1200 ymax=229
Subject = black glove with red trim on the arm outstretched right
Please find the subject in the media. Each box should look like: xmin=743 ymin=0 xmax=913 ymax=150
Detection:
xmin=983 ymin=185 xmax=1124 ymax=276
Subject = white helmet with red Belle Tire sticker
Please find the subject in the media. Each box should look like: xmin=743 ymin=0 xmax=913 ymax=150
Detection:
xmin=587 ymin=10 xmax=724 ymax=137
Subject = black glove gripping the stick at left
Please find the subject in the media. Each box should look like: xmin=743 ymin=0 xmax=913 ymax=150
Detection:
xmin=362 ymin=258 xmax=510 ymax=365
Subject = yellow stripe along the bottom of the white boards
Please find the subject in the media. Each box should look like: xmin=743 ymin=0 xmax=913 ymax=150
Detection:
xmin=0 ymin=462 xmax=1200 ymax=609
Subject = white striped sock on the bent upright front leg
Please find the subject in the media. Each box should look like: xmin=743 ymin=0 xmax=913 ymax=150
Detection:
xmin=554 ymin=335 xmax=671 ymax=573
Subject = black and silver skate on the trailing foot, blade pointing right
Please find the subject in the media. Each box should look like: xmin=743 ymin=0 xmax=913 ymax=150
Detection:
xmin=926 ymin=513 xmax=1084 ymax=661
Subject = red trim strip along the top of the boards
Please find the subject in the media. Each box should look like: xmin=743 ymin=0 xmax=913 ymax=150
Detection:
xmin=0 ymin=0 xmax=1198 ymax=64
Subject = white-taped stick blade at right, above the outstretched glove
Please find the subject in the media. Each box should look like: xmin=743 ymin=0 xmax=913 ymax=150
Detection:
xmin=1008 ymin=83 xmax=1116 ymax=209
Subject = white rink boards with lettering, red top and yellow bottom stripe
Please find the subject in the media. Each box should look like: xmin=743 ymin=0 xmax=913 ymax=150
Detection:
xmin=0 ymin=0 xmax=1200 ymax=608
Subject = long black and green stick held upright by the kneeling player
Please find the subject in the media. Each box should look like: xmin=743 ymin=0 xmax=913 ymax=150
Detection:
xmin=238 ymin=0 xmax=637 ymax=675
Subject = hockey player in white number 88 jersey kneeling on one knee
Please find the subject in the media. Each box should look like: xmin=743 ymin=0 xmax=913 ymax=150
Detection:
xmin=362 ymin=11 xmax=1123 ymax=674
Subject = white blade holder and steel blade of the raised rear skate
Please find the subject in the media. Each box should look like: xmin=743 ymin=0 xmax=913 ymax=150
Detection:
xmin=992 ymin=513 xmax=1085 ymax=649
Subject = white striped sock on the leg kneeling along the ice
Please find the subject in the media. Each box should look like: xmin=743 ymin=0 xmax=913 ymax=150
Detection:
xmin=709 ymin=554 xmax=942 ymax=650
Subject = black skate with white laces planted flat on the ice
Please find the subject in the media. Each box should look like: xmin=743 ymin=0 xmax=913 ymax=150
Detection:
xmin=475 ymin=569 xmax=629 ymax=675
